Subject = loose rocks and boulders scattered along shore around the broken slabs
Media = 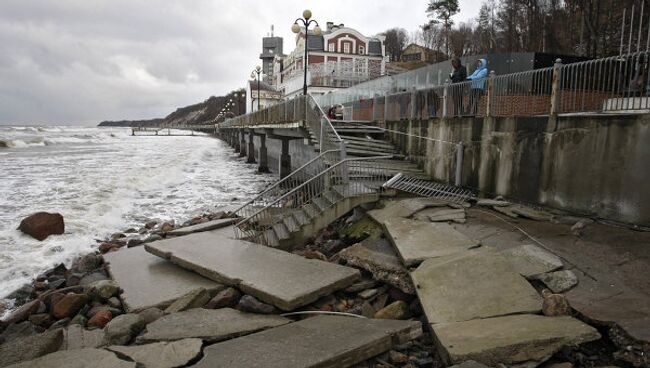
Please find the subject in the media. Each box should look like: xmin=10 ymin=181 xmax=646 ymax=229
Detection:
xmin=0 ymin=197 xmax=647 ymax=368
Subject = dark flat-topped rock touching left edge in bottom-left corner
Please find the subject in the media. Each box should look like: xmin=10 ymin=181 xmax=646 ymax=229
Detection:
xmin=0 ymin=329 xmax=63 ymax=367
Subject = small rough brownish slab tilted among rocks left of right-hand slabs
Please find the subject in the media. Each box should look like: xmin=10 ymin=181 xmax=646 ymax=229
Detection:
xmin=339 ymin=239 xmax=415 ymax=294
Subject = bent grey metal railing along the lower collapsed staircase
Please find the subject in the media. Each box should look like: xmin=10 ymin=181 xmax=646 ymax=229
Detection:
xmin=234 ymin=156 xmax=392 ymax=245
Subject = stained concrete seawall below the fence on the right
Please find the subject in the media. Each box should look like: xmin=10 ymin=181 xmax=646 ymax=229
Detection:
xmin=386 ymin=115 xmax=650 ymax=226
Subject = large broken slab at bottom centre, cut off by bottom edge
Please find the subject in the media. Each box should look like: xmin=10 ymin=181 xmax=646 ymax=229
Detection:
xmin=196 ymin=316 xmax=422 ymax=368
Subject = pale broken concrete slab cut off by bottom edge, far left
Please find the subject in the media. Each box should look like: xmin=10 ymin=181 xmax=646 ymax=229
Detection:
xmin=7 ymin=349 xmax=136 ymax=368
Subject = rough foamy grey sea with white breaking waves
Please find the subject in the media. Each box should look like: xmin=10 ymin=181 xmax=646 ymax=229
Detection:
xmin=0 ymin=126 xmax=274 ymax=302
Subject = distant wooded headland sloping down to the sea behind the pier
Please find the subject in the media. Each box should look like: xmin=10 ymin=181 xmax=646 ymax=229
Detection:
xmin=99 ymin=90 xmax=245 ymax=127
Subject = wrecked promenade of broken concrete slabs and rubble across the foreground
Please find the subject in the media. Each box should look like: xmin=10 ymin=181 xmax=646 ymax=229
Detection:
xmin=0 ymin=196 xmax=650 ymax=367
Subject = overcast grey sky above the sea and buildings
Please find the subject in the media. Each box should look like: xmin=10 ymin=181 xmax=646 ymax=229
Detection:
xmin=0 ymin=0 xmax=481 ymax=125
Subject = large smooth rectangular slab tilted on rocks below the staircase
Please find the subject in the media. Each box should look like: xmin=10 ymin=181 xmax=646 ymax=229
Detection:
xmin=145 ymin=228 xmax=361 ymax=311
